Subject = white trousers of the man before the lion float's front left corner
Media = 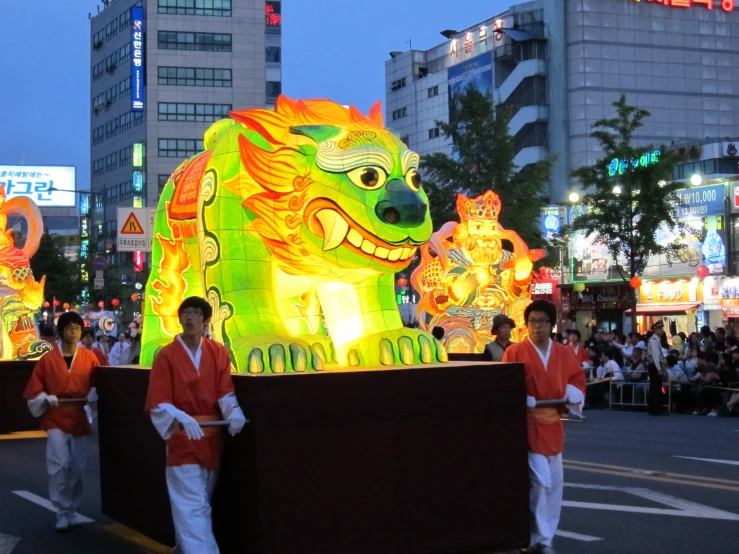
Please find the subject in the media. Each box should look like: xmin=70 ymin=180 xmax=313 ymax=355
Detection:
xmin=167 ymin=464 xmax=219 ymax=554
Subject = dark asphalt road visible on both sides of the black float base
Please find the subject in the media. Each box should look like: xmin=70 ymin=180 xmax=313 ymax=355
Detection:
xmin=0 ymin=411 xmax=739 ymax=554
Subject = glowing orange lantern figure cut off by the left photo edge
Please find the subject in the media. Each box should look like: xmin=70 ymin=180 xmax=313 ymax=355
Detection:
xmin=0 ymin=186 xmax=51 ymax=360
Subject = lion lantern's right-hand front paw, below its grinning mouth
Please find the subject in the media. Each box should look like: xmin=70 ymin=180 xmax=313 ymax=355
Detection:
xmin=344 ymin=328 xmax=448 ymax=366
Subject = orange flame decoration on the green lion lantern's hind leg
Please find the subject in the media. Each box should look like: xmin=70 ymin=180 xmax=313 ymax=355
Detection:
xmin=149 ymin=216 xmax=190 ymax=336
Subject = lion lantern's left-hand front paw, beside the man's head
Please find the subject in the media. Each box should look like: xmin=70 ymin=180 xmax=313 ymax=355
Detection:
xmin=229 ymin=335 xmax=333 ymax=373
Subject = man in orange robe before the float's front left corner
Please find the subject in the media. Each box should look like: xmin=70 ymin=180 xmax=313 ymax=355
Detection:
xmin=146 ymin=296 xmax=246 ymax=554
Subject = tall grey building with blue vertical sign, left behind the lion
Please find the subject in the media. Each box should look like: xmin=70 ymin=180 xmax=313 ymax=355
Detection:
xmin=90 ymin=0 xmax=282 ymax=273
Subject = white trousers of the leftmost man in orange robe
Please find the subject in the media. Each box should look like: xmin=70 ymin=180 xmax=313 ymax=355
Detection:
xmin=46 ymin=429 xmax=87 ymax=515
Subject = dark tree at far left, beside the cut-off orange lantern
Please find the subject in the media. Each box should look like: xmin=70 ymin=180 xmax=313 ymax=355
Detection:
xmin=31 ymin=229 xmax=81 ymax=304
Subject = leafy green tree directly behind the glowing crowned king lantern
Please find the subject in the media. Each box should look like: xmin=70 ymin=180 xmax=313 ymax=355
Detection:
xmin=421 ymin=88 xmax=551 ymax=248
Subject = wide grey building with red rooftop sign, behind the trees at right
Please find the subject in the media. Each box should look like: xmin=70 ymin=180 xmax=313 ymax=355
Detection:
xmin=385 ymin=0 xmax=739 ymax=203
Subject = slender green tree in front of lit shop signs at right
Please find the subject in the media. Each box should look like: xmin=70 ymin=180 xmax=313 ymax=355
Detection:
xmin=563 ymin=96 xmax=688 ymax=330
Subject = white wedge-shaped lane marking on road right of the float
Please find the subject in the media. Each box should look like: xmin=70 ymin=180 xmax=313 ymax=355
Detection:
xmin=562 ymin=483 xmax=739 ymax=521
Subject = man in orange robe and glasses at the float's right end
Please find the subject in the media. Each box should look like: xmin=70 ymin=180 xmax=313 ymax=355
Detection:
xmin=503 ymin=300 xmax=585 ymax=554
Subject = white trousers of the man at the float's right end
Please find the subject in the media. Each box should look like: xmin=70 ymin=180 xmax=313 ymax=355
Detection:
xmin=529 ymin=452 xmax=564 ymax=546
